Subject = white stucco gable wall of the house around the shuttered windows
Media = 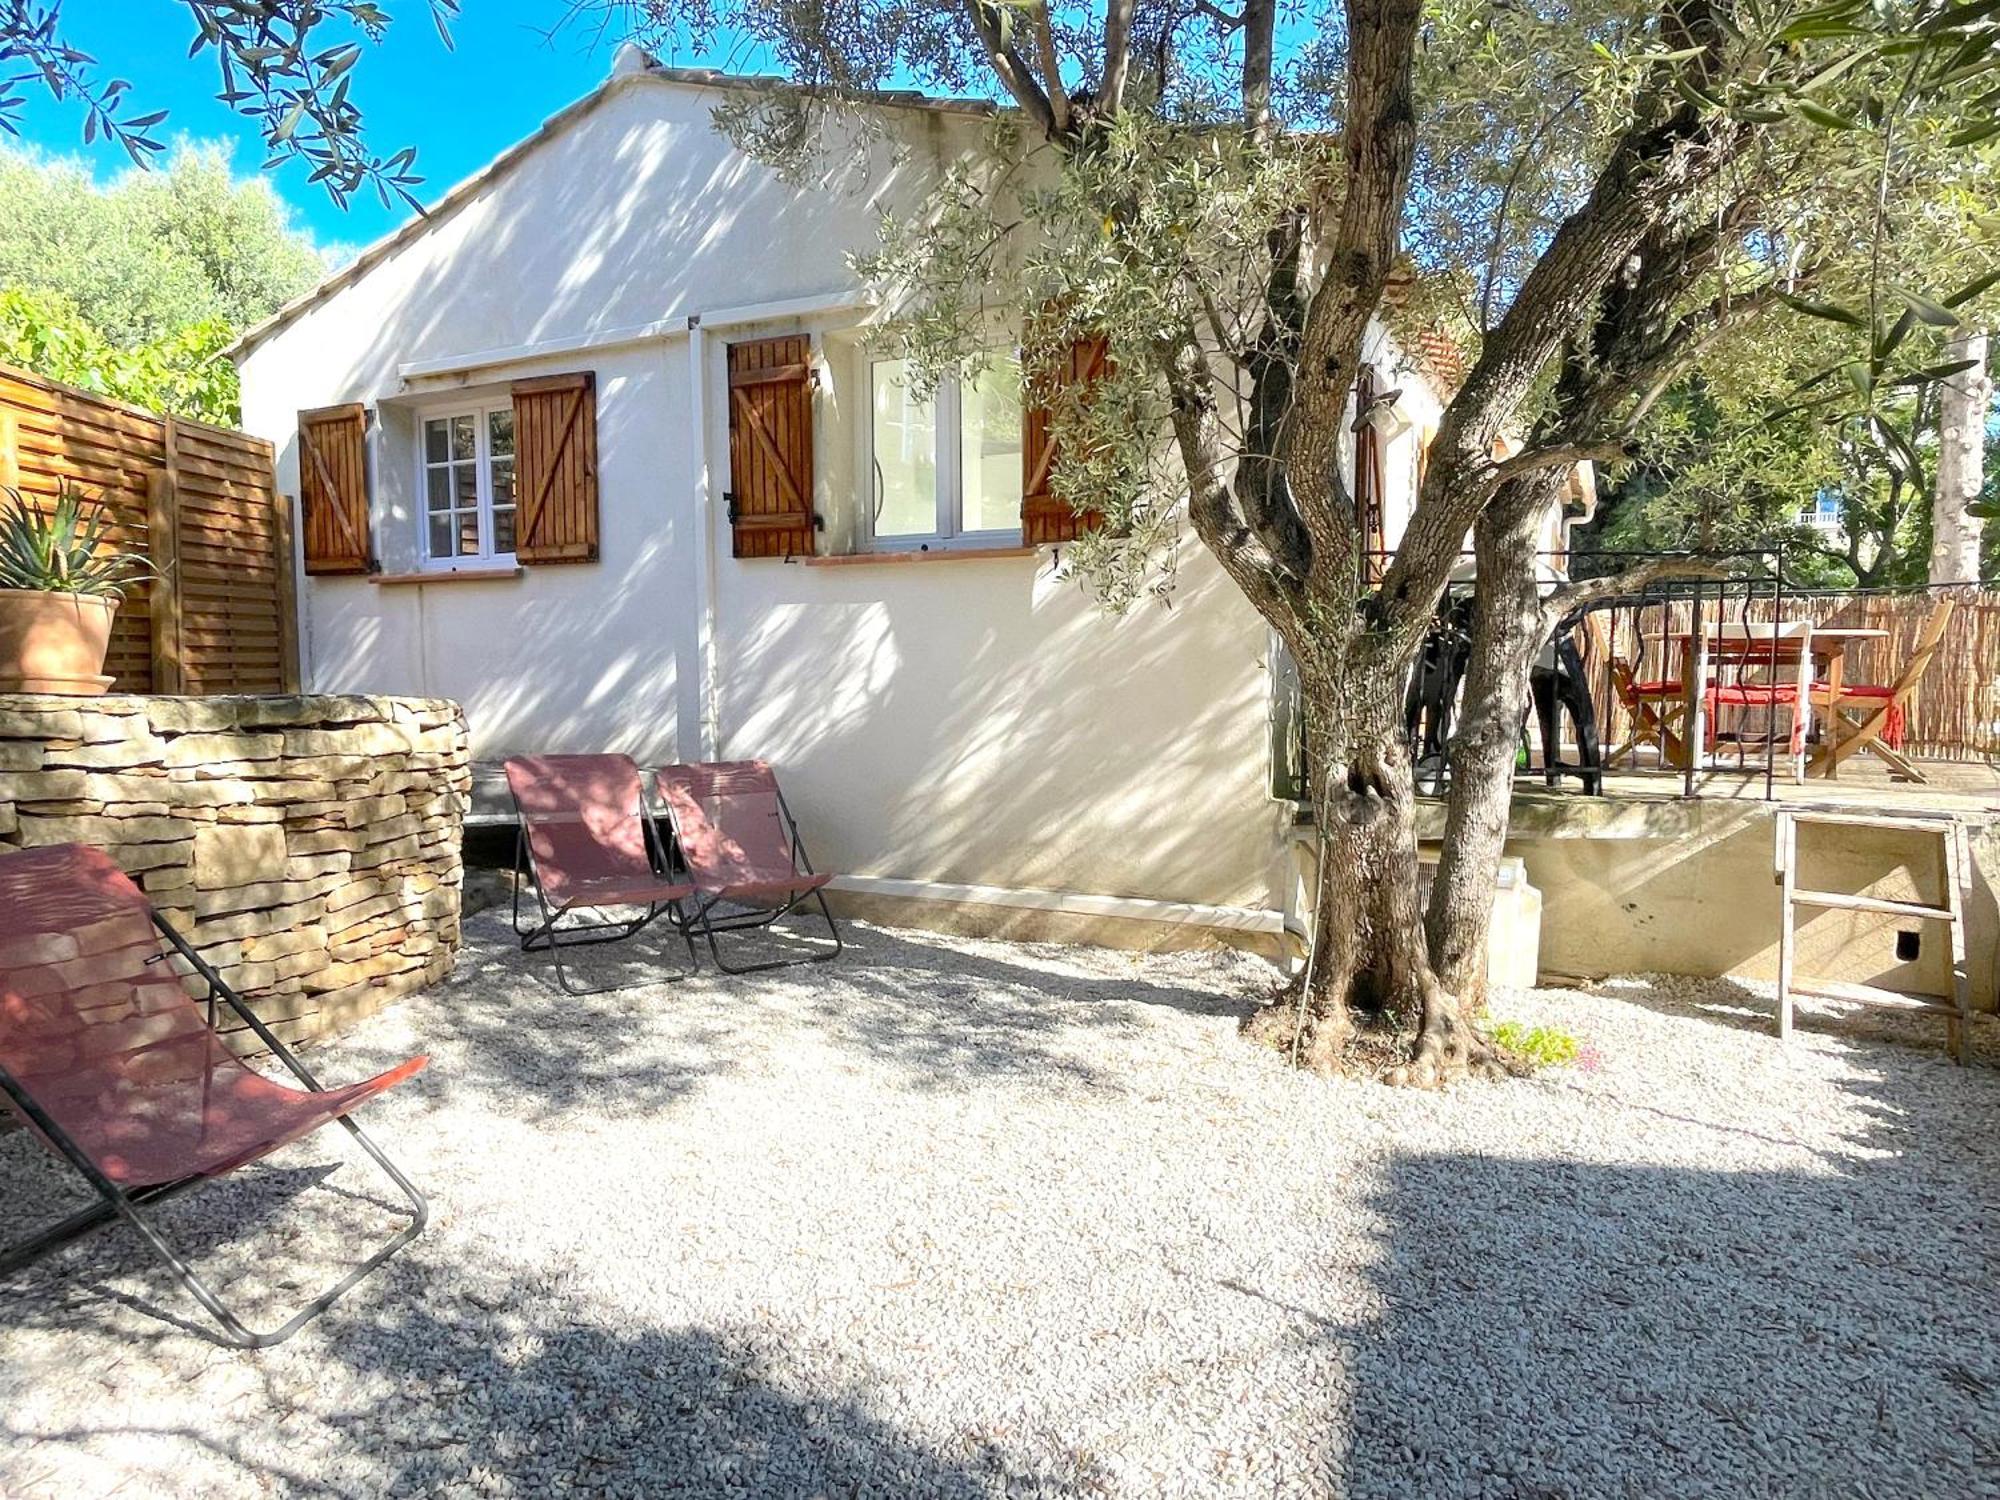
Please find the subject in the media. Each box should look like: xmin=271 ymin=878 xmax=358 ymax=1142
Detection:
xmin=242 ymin=78 xmax=1288 ymax=910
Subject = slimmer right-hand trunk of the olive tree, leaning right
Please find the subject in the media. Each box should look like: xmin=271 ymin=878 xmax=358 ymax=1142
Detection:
xmin=1424 ymin=470 xmax=1566 ymax=1014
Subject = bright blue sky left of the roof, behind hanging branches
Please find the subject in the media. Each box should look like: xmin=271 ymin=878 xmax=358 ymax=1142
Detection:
xmin=0 ymin=0 xmax=686 ymax=248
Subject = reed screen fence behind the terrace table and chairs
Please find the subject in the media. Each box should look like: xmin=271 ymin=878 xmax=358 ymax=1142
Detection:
xmin=1586 ymin=586 xmax=2000 ymax=760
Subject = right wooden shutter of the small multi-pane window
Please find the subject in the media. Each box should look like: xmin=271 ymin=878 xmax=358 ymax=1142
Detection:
xmin=514 ymin=370 xmax=598 ymax=564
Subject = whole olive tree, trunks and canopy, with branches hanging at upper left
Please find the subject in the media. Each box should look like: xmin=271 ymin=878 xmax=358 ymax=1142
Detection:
xmin=0 ymin=0 xmax=2000 ymax=1082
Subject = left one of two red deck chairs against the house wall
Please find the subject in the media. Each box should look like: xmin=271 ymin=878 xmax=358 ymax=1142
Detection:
xmin=506 ymin=756 xmax=694 ymax=994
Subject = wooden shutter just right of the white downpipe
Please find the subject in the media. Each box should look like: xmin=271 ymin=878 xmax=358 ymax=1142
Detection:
xmin=722 ymin=334 xmax=812 ymax=558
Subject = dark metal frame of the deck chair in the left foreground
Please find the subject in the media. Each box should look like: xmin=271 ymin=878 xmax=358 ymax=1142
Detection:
xmin=0 ymin=912 xmax=430 ymax=1348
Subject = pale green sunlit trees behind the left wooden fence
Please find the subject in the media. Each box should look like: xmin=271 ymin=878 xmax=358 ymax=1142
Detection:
xmin=0 ymin=144 xmax=326 ymax=424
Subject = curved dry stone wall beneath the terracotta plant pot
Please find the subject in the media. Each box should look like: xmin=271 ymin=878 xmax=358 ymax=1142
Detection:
xmin=0 ymin=694 xmax=472 ymax=1040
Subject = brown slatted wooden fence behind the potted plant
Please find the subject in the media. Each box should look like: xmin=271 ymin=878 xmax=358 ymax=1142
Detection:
xmin=0 ymin=364 xmax=298 ymax=694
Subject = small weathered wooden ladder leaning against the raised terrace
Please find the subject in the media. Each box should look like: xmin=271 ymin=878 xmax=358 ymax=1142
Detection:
xmin=1778 ymin=806 xmax=1972 ymax=1062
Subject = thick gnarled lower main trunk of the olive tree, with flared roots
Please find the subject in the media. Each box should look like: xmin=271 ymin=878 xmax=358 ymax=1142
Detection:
xmin=1244 ymin=638 xmax=1492 ymax=1086
